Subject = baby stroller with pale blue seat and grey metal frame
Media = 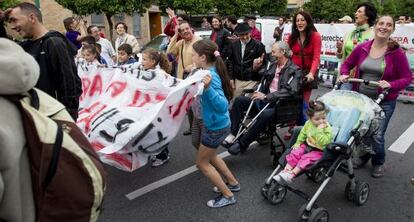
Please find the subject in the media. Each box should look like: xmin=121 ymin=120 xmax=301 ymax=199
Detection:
xmin=261 ymin=79 xmax=387 ymax=221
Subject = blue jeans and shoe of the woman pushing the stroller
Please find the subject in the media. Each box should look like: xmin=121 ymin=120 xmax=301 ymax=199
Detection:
xmin=361 ymin=100 xmax=397 ymax=166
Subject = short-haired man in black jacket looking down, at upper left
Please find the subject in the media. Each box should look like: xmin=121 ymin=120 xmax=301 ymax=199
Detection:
xmin=6 ymin=2 xmax=82 ymax=120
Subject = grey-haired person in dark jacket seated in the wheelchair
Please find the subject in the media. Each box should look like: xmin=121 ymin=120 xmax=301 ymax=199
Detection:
xmin=223 ymin=41 xmax=302 ymax=155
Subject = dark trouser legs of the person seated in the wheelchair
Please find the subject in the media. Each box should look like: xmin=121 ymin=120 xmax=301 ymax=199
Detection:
xmin=230 ymin=96 xmax=276 ymax=148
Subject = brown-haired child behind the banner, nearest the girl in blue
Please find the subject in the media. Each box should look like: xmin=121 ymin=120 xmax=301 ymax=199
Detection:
xmin=142 ymin=48 xmax=171 ymax=167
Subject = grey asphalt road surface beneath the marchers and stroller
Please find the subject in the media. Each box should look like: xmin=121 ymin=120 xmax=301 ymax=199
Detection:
xmin=99 ymin=88 xmax=414 ymax=222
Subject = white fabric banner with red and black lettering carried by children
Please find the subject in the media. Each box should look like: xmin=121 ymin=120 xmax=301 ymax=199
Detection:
xmin=77 ymin=63 xmax=208 ymax=171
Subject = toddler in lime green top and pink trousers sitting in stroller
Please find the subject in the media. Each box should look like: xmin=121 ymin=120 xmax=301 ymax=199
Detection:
xmin=274 ymin=100 xmax=332 ymax=184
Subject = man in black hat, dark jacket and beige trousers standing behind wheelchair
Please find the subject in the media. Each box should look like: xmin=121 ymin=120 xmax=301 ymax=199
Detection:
xmin=227 ymin=23 xmax=266 ymax=98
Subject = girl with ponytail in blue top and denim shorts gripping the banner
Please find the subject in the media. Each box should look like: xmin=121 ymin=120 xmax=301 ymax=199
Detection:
xmin=192 ymin=40 xmax=240 ymax=208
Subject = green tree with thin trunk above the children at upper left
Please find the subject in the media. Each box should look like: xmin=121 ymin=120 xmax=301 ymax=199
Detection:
xmin=56 ymin=0 xmax=151 ymax=39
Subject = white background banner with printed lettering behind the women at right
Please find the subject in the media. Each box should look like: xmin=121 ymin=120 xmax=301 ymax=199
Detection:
xmin=283 ymin=24 xmax=414 ymax=101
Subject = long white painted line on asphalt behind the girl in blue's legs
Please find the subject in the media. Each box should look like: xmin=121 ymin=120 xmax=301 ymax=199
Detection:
xmin=125 ymin=151 xmax=230 ymax=200
